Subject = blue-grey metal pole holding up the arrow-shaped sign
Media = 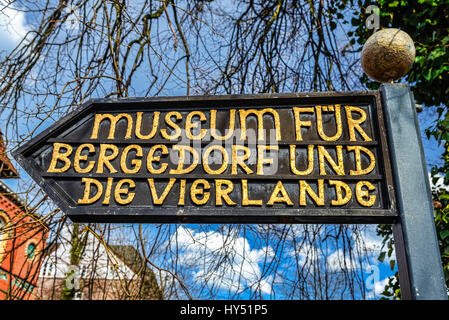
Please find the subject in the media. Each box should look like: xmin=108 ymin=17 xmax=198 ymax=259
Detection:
xmin=380 ymin=84 xmax=447 ymax=300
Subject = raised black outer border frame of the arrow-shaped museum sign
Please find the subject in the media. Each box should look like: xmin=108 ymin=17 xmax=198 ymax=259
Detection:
xmin=13 ymin=90 xmax=398 ymax=224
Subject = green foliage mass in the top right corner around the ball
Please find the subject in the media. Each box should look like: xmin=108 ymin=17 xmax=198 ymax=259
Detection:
xmin=351 ymin=0 xmax=449 ymax=106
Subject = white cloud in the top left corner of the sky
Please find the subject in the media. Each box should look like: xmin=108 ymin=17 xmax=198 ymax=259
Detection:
xmin=0 ymin=0 xmax=28 ymax=49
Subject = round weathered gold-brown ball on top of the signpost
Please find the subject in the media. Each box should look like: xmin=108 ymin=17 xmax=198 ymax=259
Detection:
xmin=362 ymin=28 xmax=415 ymax=82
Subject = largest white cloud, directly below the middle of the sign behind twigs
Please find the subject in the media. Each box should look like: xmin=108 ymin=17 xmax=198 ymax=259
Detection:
xmin=169 ymin=227 xmax=274 ymax=294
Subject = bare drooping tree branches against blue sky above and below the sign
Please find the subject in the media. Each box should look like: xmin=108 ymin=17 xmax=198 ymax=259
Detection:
xmin=0 ymin=0 xmax=388 ymax=299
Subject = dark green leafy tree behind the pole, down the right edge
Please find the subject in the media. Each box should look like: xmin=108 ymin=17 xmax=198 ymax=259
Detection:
xmin=351 ymin=0 xmax=449 ymax=298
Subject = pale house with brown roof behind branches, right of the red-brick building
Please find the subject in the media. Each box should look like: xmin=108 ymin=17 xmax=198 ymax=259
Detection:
xmin=36 ymin=226 xmax=163 ymax=300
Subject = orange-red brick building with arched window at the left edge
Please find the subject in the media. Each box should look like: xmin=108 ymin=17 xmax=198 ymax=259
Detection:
xmin=0 ymin=132 xmax=47 ymax=300
